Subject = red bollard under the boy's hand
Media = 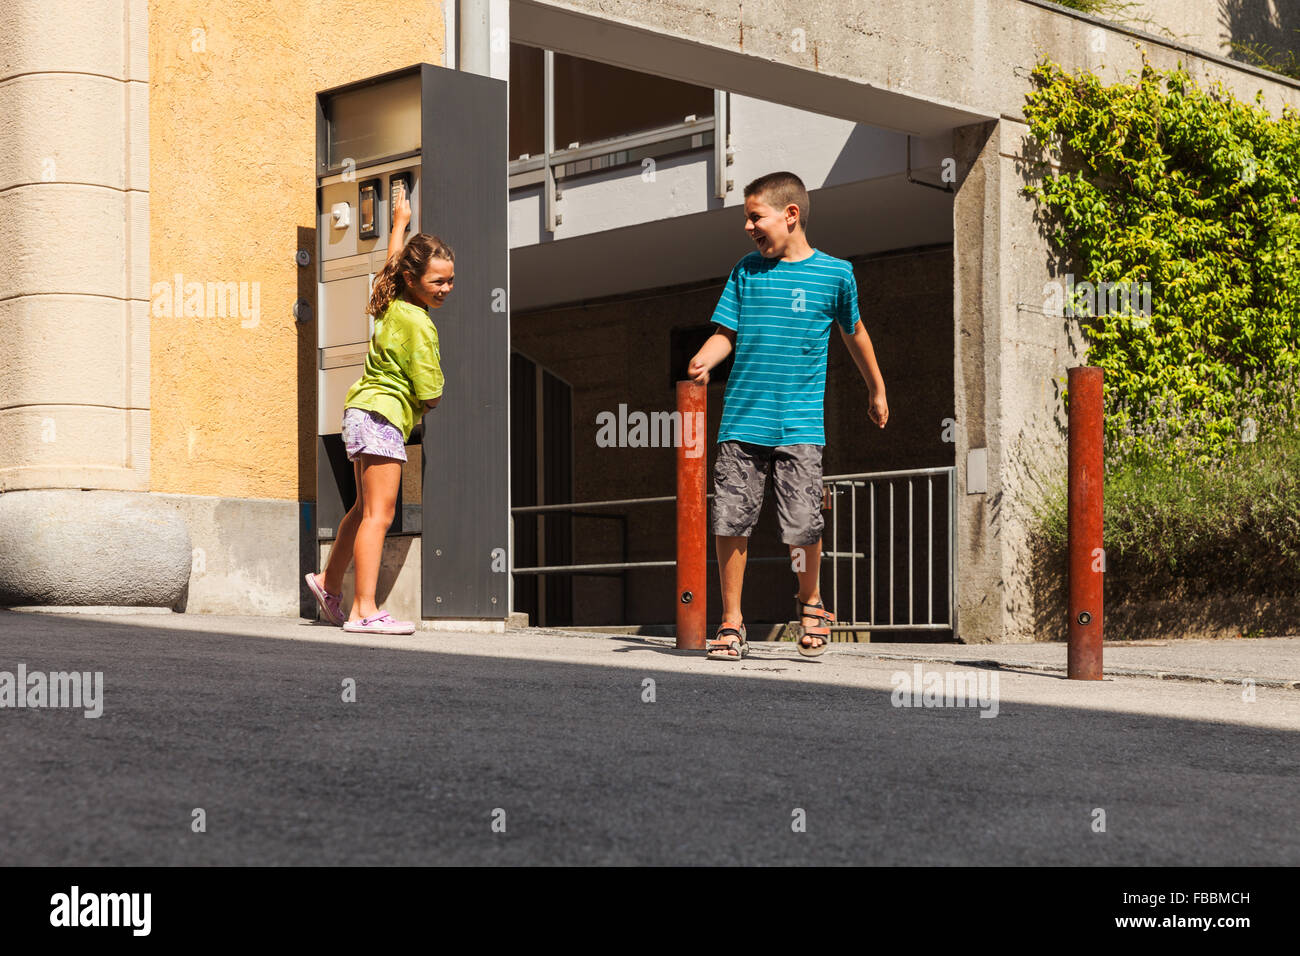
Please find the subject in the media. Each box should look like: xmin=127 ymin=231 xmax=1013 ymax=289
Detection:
xmin=676 ymin=381 xmax=709 ymax=650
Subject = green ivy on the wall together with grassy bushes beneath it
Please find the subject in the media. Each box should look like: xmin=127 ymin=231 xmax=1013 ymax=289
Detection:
xmin=1026 ymin=61 xmax=1300 ymax=600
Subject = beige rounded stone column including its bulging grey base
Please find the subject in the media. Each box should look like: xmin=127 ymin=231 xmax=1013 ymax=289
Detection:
xmin=0 ymin=0 xmax=190 ymax=606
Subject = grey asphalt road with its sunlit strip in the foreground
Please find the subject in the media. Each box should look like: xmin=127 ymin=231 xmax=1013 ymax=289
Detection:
xmin=0 ymin=611 xmax=1300 ymax=866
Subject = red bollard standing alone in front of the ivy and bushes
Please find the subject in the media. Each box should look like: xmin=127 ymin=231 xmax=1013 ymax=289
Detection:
xmin=1066 ymin=365 xmax=1106 ymax=680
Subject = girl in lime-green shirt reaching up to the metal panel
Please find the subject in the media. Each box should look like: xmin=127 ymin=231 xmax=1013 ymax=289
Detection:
xmin=307 ymin=190 xmax=455 ymax=633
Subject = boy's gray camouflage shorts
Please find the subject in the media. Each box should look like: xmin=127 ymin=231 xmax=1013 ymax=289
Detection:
xmin=712 ymin=441 xmax=826 ymax=545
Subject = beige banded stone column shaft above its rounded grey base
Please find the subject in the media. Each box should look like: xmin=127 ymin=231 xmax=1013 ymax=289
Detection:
xmin=0 ymin=0 xmax=150 ymax=492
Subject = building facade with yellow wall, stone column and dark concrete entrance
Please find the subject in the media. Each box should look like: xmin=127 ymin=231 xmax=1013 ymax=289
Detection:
xmin=0 ymin=0 xmax=1300 ymax=641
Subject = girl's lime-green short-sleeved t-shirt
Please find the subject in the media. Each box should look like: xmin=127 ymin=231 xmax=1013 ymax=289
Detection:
xmin=343 ymin=299 xmax=443 ymax=441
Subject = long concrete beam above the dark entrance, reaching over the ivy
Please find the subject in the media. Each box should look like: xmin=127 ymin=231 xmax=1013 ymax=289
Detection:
xmin=511 ymin=0 xmax=1300 ymax=133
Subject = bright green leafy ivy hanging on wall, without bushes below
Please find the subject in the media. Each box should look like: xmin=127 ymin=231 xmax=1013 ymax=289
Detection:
xmin=1024 ymin=61 xmax=1300 ymax=466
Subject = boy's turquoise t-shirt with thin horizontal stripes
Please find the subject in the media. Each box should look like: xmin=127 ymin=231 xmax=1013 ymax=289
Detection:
xmin=712 ymin=250 xmax=858 ymax=447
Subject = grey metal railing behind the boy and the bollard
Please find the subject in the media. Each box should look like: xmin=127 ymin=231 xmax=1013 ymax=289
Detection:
xmin=511 ymin=466 xmax=957 ymax=631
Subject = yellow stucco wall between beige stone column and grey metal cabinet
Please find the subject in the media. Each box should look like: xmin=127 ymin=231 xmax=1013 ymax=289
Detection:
xmin=150 ymin=0 xmax=443 ymax=499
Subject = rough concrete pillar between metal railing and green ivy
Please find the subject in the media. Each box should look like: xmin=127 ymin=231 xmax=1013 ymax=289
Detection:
xmin=953 ymin=117 xmax=1071 ymax=643
